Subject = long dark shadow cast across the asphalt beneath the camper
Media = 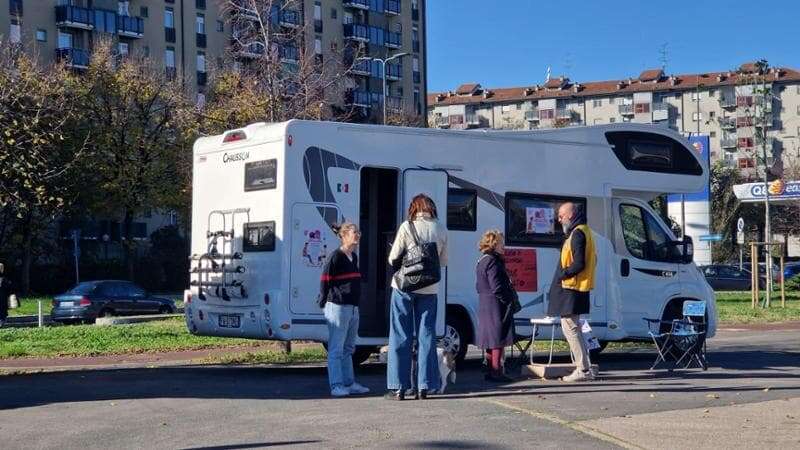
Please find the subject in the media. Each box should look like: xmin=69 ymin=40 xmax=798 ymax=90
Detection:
xmin=0 ymin=349 xmax=800 ymax=412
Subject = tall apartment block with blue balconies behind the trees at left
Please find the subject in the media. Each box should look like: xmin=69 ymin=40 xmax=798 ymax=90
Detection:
xmin=0 ymin=0 xmax=427 ymax=122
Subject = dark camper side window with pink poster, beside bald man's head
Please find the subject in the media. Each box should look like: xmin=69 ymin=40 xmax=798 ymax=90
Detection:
xmin=506 ymin=193 xmax=586 ymax=247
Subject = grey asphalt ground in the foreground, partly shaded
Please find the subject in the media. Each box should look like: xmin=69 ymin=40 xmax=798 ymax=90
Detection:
xmin=0 ymin=329 xmax=800 ymax=449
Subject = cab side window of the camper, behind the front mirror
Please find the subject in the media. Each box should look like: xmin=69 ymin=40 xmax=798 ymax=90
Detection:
xmin=619 ymin=204 xmax=680 ymax=262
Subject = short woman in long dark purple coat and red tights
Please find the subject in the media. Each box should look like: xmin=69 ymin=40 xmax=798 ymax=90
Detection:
xmin=475 ymin=230 xmax=516 ymax=382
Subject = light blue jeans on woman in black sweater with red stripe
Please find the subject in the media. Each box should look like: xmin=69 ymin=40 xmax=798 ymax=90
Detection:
xmin=325 ymin=302 xmax=358 ymax=389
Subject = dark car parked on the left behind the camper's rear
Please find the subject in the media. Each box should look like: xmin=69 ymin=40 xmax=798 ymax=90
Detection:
xmin=50 ymin=280 xmax=175 ymax=323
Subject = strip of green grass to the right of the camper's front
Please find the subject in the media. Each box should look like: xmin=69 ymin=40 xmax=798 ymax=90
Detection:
xmin=717 ymin=291 xmax=800 ymax=324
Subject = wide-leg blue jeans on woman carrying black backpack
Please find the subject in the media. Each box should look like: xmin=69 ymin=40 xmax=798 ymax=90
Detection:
xmin=386 ymin=289 xmax=441 ymax=390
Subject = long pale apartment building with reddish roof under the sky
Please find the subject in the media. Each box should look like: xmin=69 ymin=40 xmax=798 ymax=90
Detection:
xmin=428 ymin=63 xmax=800 ymax=177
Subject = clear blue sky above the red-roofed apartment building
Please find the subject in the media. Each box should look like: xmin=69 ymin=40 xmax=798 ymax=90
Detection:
xmin=427 ymin=0 xmax=800 ymax=92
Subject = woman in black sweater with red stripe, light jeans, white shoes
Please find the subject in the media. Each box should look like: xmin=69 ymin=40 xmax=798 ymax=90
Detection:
xmin=319 ymin=222 xmax=369 ymax=397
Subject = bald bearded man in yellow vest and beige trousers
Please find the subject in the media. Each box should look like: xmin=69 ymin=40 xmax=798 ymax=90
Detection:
xmin=547 ymin=203 xmax=597 ymax=382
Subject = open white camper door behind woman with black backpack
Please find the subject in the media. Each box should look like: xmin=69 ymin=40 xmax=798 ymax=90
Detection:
xmin=402 ymin=169 xmax=447 ymax=337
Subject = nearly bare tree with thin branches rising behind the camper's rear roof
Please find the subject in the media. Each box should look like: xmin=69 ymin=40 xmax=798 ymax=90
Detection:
xmin=212 ymin=0 xmax=356 ymax=132
